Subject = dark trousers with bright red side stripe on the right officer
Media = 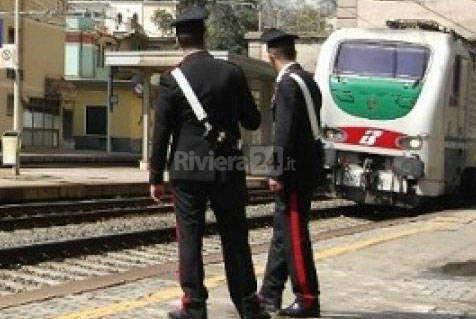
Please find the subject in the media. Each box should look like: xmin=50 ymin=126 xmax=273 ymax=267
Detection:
xmin=260 ymin=189 xmax=319 ymax=305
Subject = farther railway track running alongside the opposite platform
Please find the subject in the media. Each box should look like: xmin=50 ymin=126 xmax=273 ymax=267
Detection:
xmin=0 ymin=187 xmax=316 ymax=269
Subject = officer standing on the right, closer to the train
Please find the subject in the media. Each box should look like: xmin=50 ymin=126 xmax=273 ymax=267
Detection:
xmin=259 ymin=29 xmax=321 ymax=318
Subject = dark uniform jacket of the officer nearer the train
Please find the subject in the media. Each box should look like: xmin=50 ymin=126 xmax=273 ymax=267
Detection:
xmin=272 ymin=63 xmax=321 ymax=189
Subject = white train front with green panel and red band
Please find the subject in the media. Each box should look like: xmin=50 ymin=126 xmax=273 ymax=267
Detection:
xmin=316 ymin=29 xmax=451 ymax=206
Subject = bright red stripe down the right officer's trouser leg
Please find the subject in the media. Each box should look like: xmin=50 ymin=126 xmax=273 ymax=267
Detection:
xmin=289 ymin=193 xmax=312 ymax=306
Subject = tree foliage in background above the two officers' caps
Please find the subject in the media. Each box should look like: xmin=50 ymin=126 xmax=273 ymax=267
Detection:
xmin=174 ymin=0 xmax=336 ymax=53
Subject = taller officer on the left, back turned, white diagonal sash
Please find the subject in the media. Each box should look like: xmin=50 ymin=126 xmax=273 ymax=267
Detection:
xmin=150 ymin=7 xmax=270 ymax=319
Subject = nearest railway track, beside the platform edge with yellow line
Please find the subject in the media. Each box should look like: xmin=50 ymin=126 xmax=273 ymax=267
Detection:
xmin=0 ymin=190 xmax=468 ymax=309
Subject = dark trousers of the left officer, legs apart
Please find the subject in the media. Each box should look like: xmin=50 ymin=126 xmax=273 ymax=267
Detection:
xmin=172 ymin=180 xmax=256 ymax=315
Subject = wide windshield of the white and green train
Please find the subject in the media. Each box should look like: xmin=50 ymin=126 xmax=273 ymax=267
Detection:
xmin=334 ymin=42 xmax=429 ymax=80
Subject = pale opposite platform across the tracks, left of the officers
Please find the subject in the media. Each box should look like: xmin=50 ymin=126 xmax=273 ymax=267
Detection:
xmin=0 ymin=166 xmax=268 ymax=204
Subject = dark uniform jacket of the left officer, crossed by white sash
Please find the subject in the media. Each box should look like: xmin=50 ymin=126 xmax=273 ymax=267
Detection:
xmin=150 ymin=51 xmax=261 ymax=184
